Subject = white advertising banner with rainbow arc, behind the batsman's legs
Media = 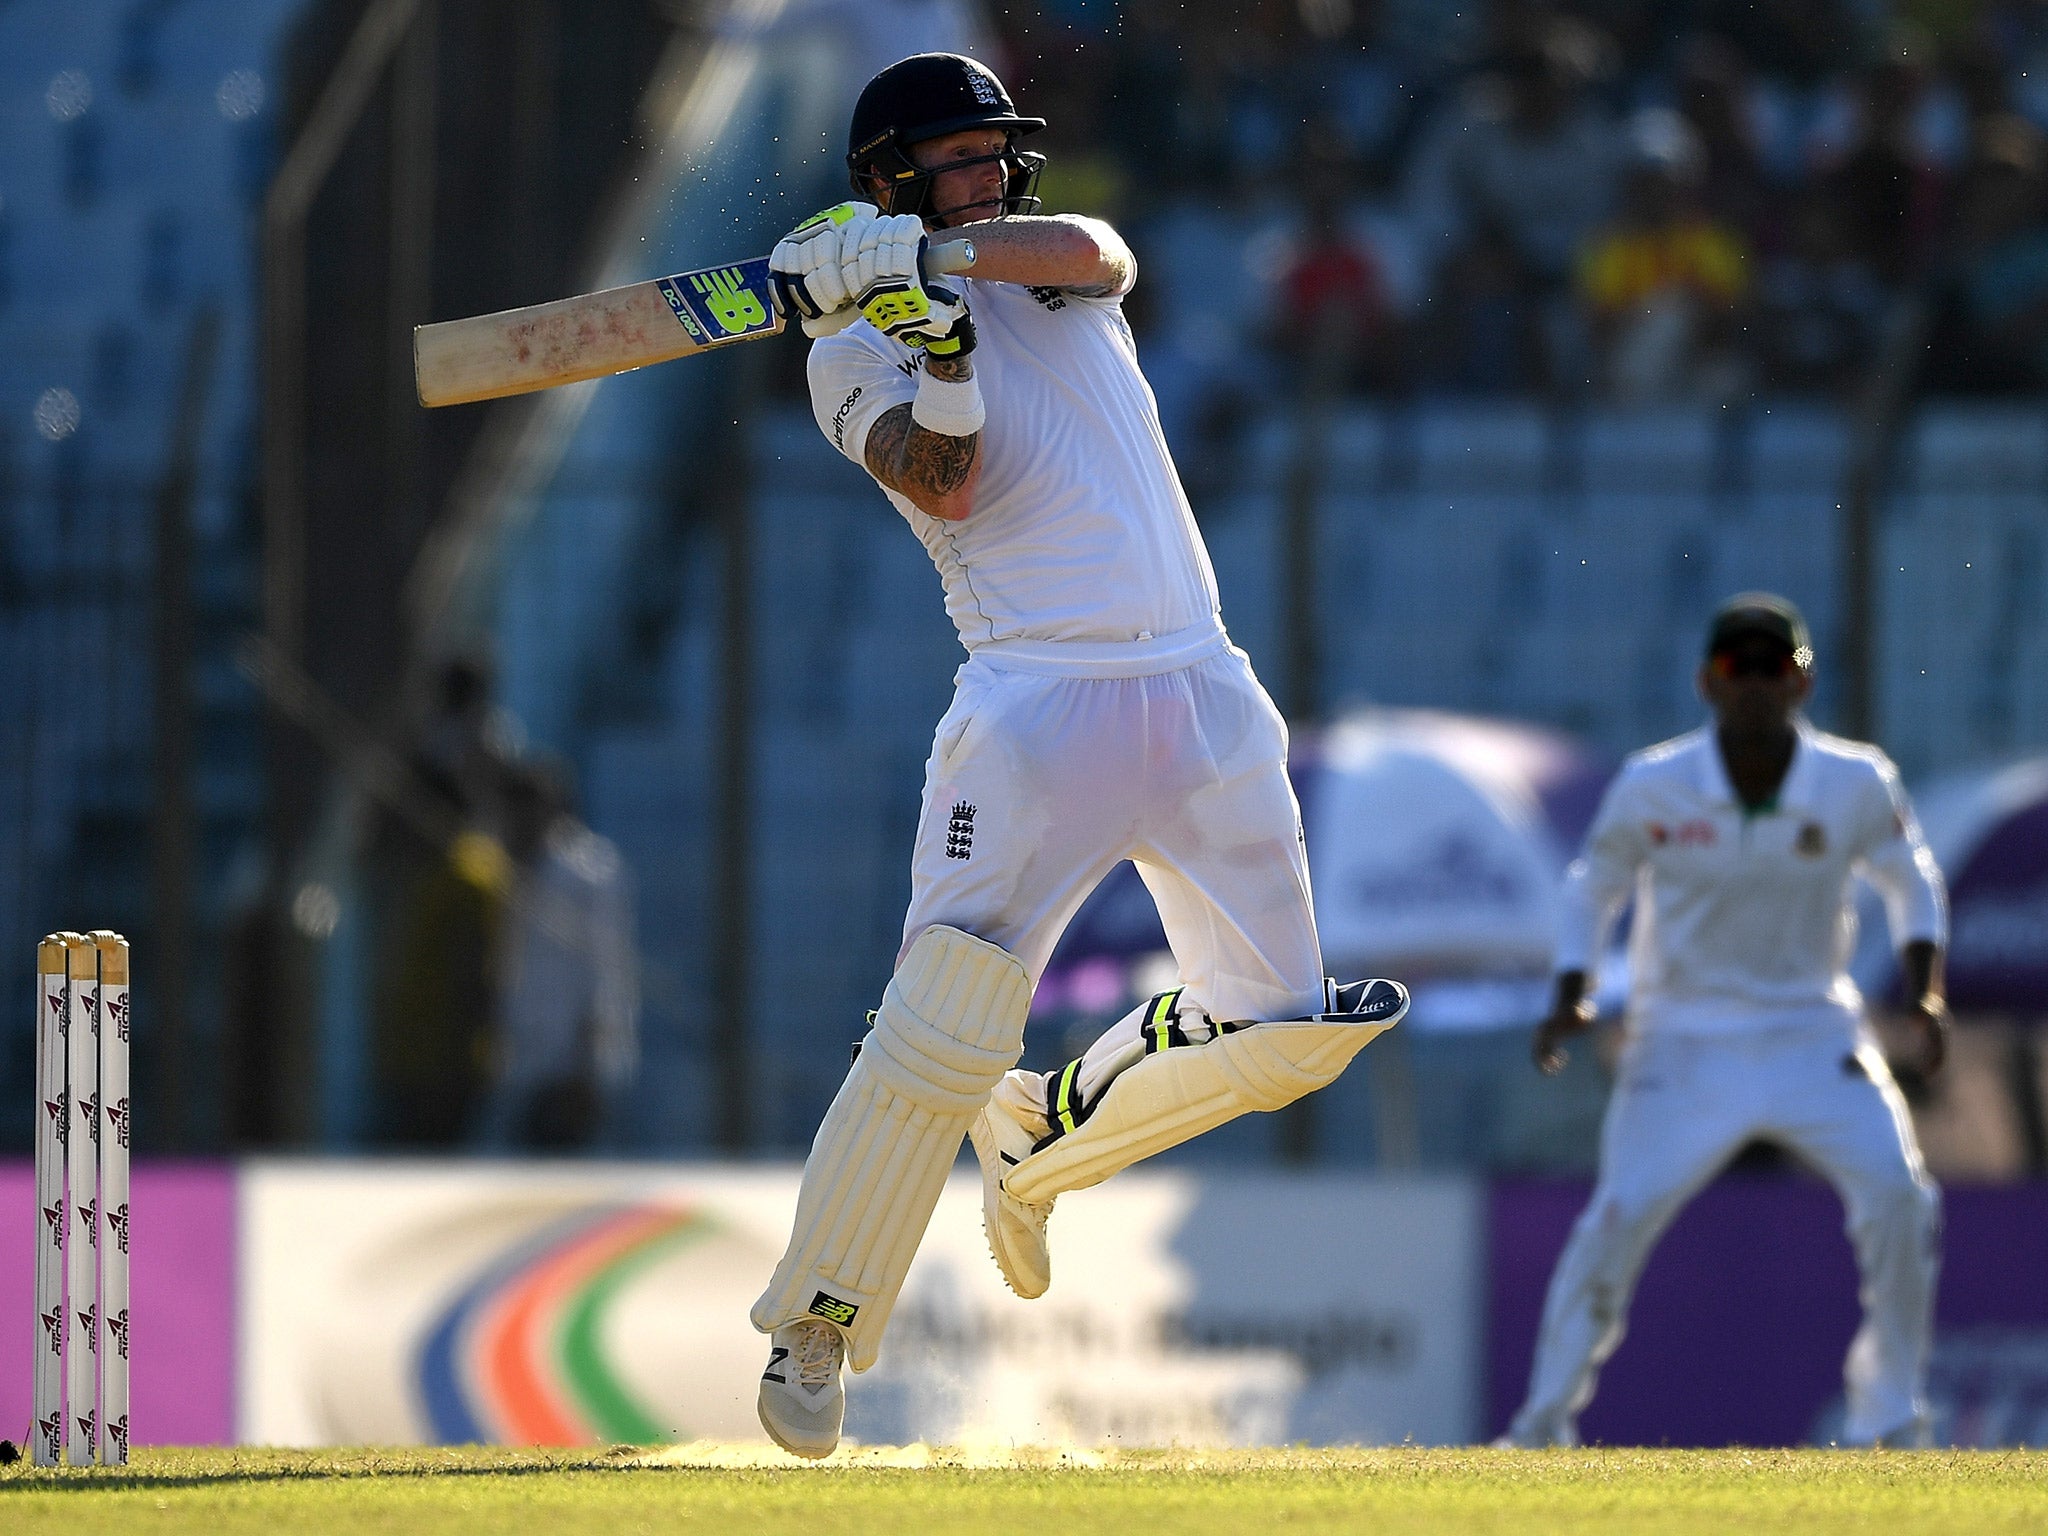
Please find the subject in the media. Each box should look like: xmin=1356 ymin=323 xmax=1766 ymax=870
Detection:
xmin=238 ymin=1161 xmax=1483 ymax=1446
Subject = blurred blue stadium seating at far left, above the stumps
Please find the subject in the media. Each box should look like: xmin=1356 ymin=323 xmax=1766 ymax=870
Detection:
xmin=0 ymin=0 xmax=301 ymax=1141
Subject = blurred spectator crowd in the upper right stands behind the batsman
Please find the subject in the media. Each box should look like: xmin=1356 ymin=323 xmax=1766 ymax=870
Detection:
xmin=995 ymin=0 xmax=2048 ymax=405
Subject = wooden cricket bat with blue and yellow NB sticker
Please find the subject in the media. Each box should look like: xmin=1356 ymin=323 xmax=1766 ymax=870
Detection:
xmin=412 ymin=240 xmax=975 ymax=406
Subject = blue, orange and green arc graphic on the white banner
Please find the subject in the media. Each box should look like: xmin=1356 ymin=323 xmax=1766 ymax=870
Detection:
xmin=416 ymin=1204 xmax=717 ymax=1446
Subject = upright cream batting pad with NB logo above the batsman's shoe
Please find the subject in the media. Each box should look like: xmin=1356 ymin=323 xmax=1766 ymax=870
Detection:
xmin=752 ymin=928 xmax=1030 ymax=1370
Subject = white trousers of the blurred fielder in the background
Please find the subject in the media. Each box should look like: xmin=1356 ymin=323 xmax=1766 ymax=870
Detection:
xmin=1507 ymin=1028 xmax=1939 ymax=1446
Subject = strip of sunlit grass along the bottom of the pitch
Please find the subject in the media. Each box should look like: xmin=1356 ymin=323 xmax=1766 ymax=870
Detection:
xmin=0 ymin=1446 xmax=2048 ymax=1536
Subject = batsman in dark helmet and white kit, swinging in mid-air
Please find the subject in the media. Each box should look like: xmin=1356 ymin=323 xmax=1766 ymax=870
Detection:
xmin=752 ymin=53 xmax=1407 ymax=1456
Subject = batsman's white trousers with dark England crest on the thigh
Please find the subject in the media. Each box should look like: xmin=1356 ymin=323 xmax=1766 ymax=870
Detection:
xmin=903 ymin=649 xmax=1323 ymax=1020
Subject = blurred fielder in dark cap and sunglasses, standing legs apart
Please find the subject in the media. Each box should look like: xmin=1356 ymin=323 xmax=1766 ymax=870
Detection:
xmin=1505 ymin=592 xmax=1948 ymax=1446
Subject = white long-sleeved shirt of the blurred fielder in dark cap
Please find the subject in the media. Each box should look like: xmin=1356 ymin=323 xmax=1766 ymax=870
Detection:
xmin=1556 ymin=721 xmax=1948 ymax=1032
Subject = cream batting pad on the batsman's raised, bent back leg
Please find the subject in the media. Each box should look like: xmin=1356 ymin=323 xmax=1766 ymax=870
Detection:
xmin=1004 ymin=981 xmax=1409 ymax=1204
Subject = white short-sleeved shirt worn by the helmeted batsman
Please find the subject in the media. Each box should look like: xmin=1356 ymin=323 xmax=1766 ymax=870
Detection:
xmin=809 ymin=279 xmax=1229 ymax=676
